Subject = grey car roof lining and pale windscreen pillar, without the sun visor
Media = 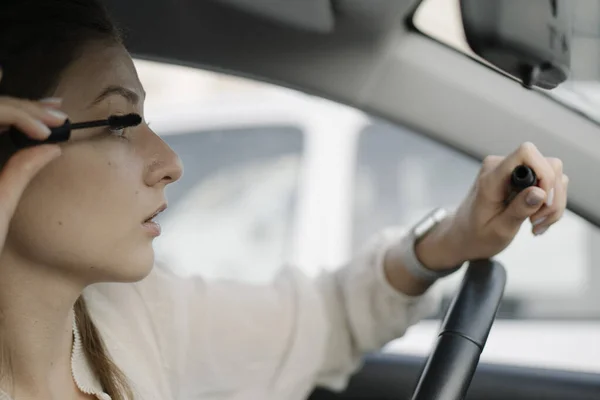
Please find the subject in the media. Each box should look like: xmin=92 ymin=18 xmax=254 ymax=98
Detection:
xmin=105 ymin=0 xmax=600 ymax=225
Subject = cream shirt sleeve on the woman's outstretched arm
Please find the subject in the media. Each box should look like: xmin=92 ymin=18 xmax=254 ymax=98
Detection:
xmin=131 ymin=230 xmax=438 ymax=398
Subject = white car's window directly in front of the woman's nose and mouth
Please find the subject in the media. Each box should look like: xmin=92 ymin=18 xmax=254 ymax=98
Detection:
xmin=155 ymin=126 xmax=303 ymax=282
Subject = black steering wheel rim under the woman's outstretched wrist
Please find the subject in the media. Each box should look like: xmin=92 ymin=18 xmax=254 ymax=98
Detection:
xmin=412 ymin=260 xmax=506 ymax=400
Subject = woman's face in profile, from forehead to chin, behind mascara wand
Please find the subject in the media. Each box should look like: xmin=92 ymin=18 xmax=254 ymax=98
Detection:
xmin=3 ymin=44 xmax=182 ymax=284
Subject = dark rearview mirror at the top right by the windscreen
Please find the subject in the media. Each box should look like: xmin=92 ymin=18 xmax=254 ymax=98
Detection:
xmin=460 ymin=0 xmax=573 ymax=89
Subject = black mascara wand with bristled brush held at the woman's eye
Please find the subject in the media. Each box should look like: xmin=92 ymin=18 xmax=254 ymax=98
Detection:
xmin=8 ymin=114 xmax=142 ymax=148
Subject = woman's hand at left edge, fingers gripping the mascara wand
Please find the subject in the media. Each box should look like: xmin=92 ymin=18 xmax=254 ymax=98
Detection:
xmin=0 ymin=70 xmax=66 ymax=242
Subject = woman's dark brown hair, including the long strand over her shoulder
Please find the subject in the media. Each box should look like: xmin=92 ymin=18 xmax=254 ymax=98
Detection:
xmin=0 ymin=0 xmax=133 ymax=400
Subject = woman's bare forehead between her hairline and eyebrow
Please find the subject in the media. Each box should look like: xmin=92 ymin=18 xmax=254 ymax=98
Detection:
xmin=54 ymin=43 xmax=144 ymax=110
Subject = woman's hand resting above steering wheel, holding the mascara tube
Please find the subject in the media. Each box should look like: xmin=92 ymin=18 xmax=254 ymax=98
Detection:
xmin=417 ymin=143 xmax=569 ymax=270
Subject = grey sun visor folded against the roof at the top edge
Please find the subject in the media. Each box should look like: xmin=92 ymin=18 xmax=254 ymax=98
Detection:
xmin=213 ymin=0 xmax=335 ymax=33
